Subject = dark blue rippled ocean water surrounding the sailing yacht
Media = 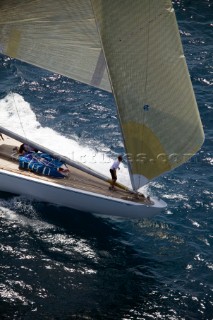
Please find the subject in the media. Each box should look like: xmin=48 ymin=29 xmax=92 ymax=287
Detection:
xmin=0 ymin=0 xmax=213 ymax=320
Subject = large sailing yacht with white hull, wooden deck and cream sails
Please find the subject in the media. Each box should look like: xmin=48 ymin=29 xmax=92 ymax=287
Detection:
xmin=0 ymin=0 xmax=204 ymax=218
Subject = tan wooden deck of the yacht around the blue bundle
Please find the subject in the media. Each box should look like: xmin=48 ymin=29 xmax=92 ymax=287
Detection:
xmin=0 ymin=135 xmax=150 ymax=204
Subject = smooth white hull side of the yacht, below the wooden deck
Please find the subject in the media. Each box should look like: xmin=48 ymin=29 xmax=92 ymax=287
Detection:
xmin=0 ymin=170 xmax=166 ymax=219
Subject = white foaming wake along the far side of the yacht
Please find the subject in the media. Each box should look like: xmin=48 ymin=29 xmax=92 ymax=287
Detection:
xmin=0 ymin=93 xmax=131 ymax=187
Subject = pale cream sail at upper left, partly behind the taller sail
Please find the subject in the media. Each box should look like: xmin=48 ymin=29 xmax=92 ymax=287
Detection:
xmin=0 ymin=0 xmax=111 ymax=91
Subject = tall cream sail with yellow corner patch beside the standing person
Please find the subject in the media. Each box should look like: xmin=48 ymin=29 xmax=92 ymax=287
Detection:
xmin=92 ymin=0 xmax=204 ymax=189
